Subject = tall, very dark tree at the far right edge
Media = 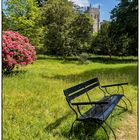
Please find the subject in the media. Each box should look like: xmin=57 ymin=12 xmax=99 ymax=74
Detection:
xmin=110 ymin=0 xmax=138 ymax=55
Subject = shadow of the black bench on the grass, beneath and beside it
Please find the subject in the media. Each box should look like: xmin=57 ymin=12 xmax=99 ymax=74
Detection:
xmin=44 ymin=105 xmax=126 ymax=140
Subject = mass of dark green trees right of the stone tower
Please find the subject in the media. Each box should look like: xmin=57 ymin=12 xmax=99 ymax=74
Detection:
xmin=91 ymin=0 xmax=138 ymax=57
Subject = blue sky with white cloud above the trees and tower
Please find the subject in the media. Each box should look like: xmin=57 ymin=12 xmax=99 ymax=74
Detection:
xmin=2 ymin=0 xmax=119 ymax=21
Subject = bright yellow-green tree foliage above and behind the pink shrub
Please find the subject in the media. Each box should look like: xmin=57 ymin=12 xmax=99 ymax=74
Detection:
xmin=3 ymin=0 xmax=43 ymax=47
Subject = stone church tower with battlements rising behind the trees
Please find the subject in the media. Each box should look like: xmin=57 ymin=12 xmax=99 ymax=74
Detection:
xmin=86 ymin=5 xmax=100 ymax=32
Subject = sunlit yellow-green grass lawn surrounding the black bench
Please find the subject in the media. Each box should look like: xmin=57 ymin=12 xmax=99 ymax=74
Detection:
xmin=2 ymin=57 xmax=138 ymax=140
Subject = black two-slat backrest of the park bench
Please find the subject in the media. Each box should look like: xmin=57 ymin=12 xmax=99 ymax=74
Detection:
xmin=64 ymin=78 xmax=100 ymax=103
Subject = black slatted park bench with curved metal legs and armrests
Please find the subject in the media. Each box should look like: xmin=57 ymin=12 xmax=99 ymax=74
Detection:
xmin=64 ymin=78 xmax=132 ymax=140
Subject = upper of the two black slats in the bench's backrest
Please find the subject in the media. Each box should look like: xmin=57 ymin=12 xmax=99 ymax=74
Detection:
xmin=64 ymin=78 xmax=99 ymax=96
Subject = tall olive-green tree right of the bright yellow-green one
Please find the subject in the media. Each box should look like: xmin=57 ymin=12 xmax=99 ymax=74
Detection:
xmin=42 ymin=0 xmax=76 ymax=55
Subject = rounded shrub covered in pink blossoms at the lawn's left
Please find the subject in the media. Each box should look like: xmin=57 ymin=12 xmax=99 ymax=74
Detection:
xmin=2 ymin=31 xmax=36 ymax=72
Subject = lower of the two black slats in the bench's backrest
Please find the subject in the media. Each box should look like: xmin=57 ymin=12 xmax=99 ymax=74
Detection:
xmin=67 ymin=83 xmax=99 ymax=101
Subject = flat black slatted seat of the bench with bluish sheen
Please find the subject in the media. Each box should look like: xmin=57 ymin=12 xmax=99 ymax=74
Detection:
xmin=77 ymin=94 xmax=123 ymax=121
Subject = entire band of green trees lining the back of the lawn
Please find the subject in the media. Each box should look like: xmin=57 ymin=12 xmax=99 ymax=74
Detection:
xmin=2 ymin=0 xmax=138 ymax=57
